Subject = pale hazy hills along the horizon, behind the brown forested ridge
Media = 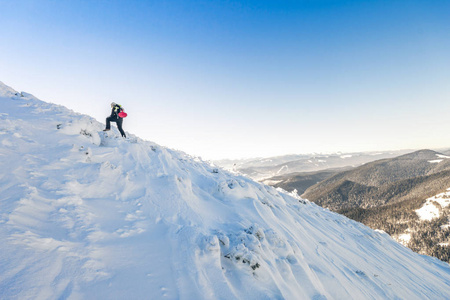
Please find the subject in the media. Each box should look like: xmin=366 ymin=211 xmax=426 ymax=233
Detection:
xmin=214 ymin=150 xmax=411 ymax=180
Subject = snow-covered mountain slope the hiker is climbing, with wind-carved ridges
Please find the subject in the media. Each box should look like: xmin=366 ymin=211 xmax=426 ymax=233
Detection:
xmin=0 ymin=83 xmax=450 ymax=299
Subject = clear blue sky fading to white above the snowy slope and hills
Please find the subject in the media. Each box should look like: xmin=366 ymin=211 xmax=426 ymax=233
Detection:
xmin=0 ymin=0 xmax=450 ymax=159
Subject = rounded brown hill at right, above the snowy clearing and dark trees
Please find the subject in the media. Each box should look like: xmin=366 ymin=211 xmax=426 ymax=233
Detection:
xmin=303 ymin=150 xmax=450 ymax=210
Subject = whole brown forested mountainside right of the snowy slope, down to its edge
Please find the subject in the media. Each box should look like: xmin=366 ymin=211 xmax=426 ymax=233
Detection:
xmin=264 ymin=150 xmax=450 ymax=262
